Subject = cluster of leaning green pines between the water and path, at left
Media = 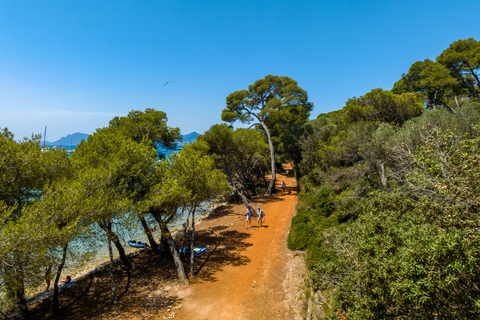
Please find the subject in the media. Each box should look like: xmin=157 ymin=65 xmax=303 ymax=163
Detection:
xmin=0 ymin=109 xmax=229 ymax=319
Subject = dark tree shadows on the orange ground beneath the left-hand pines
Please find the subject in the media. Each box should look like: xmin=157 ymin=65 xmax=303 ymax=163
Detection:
xmin=29 ymin=216 xmax=252 ymax=320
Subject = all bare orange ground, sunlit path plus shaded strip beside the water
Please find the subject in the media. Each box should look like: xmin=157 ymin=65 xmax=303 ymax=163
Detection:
xmin=32 ymin=167 xmax=306 ymax=320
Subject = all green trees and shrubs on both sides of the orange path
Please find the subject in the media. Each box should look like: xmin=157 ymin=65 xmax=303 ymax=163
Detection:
xmin=0 ymin=39 xmax=480 ymax=319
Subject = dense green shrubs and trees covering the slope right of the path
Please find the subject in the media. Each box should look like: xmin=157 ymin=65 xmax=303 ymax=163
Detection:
xmin=288 ymin=39 xmax=480 ymax=319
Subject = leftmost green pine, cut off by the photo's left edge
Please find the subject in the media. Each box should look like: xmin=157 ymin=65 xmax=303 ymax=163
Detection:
xmin=0 ymin=129 xmax=75 ymax=317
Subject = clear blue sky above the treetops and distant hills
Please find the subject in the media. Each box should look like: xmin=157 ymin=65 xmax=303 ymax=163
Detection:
xmin=0 ymin=0 xmax=480 ymax=141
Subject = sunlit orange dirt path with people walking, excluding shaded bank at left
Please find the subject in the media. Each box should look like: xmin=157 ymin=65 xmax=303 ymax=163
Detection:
xmin=175 ymin=168 xmax=304 ymax=320
